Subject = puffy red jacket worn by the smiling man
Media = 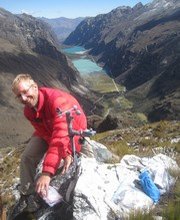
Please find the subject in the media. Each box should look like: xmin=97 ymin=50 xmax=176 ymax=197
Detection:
xmin=24 ymin=87 xmax=87 ymax=174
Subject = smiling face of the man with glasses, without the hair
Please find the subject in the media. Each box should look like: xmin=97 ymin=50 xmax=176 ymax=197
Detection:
xmin=14 ymin=81 xmax=38 ymax=107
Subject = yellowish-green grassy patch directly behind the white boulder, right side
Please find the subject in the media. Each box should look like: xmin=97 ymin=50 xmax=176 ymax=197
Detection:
xmin=94 ymin=121 xmax=180 ymax=157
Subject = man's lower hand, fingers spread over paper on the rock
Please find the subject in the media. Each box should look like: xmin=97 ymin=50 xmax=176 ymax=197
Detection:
xmin=36 ymin=173 xmax=51 ymax=197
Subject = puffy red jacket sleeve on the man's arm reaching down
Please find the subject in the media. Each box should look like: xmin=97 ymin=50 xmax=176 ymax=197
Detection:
xmin=43 ymin=97 xmax=72 ymax=174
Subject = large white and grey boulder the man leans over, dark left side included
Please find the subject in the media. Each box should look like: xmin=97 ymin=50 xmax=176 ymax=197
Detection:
xmin=30 ymin=141 xmax=179 ymax=220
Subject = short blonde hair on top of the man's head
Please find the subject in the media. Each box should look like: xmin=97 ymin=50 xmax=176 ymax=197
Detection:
xmin=11 ymin=73 xmax=37 ymax=92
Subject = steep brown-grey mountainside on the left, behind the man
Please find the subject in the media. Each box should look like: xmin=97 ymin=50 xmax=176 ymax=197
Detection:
xmin=0 ymin=8 xmax=94 ymax=147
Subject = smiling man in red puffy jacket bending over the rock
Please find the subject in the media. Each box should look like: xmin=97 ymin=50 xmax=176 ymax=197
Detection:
xmin=12 ymin=74 xmax=87 ymax=201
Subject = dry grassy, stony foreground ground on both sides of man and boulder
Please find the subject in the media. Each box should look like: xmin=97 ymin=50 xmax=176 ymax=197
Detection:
xmin=0 ymin=121 xmax=180 ymax=219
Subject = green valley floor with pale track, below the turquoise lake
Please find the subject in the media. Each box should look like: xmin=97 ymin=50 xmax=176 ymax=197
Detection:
xmin=84 ymin=70 xmax=147 ymax=127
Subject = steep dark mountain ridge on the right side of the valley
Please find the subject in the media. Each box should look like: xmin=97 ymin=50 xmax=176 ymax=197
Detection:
xmin=64 ymin=0 xmax=180 ymax=121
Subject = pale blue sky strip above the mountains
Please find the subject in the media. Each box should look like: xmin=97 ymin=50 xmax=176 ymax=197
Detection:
xmin=0 ymin=0 xmax=152 ymax=18
